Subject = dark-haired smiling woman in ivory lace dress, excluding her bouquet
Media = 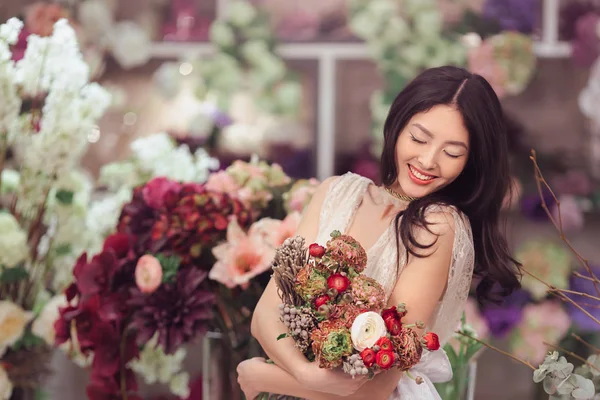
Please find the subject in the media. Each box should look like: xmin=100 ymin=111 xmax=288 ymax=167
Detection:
xmin=238 ymin=67 xmax=520 ymax=400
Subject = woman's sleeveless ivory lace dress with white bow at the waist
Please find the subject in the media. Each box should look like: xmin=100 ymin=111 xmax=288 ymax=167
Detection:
xmin=317 ymin=173 xmax=474 ymax=400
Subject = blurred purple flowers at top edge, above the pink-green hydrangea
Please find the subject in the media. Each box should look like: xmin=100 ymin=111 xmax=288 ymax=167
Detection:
xmin=483 ymin=0 xmax=540 ymax=33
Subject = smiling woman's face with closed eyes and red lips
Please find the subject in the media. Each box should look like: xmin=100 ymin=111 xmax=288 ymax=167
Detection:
xmin=394 ymin=105 xmax=469 ymax=198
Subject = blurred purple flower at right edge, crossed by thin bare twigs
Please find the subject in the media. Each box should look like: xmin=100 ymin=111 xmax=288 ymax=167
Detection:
xmin=567 ymin=266 xmax=600 ymax=332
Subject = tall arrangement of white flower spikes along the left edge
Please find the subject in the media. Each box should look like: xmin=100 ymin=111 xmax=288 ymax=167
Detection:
xmin=0 ymin=18 xmax=111 ymax=398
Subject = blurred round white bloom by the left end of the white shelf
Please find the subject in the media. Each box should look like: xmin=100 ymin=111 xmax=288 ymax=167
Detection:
xmin=111 ymin=21 xmax=150 ymax=69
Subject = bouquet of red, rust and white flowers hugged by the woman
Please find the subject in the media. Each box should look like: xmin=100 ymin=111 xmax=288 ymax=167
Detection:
xmin=273 ymin=231 xmax=439 ymax=381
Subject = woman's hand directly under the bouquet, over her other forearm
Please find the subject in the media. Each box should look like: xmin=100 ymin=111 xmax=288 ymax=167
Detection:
xmin=297 ymin=363 xmax=368 ymax=396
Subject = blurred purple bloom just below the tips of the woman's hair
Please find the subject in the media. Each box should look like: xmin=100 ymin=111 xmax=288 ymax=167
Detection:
xmin=481 ymin=290 xmax=530 ymax=339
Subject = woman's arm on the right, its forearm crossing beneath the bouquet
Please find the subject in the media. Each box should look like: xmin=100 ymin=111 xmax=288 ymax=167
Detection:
xmin=245 ymin=212 xmax=454 ymax=400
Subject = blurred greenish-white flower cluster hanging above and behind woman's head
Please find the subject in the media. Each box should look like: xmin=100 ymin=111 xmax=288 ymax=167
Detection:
xmin=350 ymin=0 xmax=466 ymax=155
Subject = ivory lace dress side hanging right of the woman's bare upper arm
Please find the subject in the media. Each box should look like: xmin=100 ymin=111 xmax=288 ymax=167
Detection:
xmin=430 ymin=207 xmax=475 ymax=345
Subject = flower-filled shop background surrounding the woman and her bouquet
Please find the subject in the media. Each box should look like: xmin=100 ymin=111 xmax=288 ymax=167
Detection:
xmin=0 ymin=0 xmax=600 ymax=400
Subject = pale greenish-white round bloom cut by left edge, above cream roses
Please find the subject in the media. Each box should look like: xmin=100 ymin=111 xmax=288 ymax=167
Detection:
xmin=0 ymin=213 xmax=29 ymax=268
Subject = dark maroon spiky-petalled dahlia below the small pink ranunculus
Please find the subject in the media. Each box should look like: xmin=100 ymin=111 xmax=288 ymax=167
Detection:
xmin=129 ymin=268 xmax=215 ymax=353
